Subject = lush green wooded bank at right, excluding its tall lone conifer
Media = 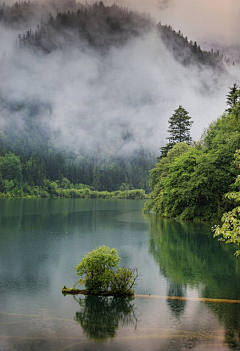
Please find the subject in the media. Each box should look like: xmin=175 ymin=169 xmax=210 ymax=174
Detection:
xmin=145 ymin=84 xmax=240 ymax=220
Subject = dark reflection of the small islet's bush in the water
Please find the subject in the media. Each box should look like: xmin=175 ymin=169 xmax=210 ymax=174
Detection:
xmin=74 ymin=296 xmax=137 ymax=341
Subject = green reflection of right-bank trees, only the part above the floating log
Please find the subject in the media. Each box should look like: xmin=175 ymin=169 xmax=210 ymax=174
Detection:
xmin=146 ymin=216 xmax=240 ymax=300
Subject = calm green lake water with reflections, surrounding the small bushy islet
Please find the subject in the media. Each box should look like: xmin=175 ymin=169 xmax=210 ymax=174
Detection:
xmin=0 ymin=199 xmax=240 ymax=351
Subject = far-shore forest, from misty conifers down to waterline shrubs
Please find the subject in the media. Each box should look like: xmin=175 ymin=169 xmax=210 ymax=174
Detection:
xmin=0 ymin=132 xmax=154 ymax=198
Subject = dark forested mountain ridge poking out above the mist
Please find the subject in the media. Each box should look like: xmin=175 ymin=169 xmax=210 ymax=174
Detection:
xmin=9 ymin=1 xmax=230 ymax=69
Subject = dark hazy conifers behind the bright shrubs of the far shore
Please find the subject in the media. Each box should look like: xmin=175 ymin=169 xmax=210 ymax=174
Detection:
xmin=0 ymin=127 xmax=156 ymax=196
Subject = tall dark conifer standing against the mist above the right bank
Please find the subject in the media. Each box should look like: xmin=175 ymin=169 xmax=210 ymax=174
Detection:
xmin=160 ymin=105 xmax=193 ymax=158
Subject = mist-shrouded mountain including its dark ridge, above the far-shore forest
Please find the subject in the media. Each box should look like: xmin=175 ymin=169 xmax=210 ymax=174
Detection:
xmin=0 ymin=0 xmax=239 ymax=192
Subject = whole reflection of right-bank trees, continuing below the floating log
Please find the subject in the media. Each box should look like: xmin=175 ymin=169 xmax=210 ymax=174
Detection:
xmin=145 ymin=215 xmax=240 ymax=350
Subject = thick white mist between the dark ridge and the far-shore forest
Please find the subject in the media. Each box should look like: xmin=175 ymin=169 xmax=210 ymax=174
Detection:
xmin=0 ymin=0 xmax=239 ymax=155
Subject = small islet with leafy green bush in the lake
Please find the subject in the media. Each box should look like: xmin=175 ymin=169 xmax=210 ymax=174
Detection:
xmin=62 ymin=245 xmax=138 ymax=297
